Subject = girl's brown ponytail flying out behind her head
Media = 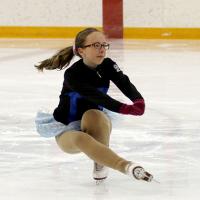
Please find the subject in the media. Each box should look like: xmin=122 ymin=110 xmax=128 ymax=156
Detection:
xmin=35 ymin=46 xmax=74 ymax=71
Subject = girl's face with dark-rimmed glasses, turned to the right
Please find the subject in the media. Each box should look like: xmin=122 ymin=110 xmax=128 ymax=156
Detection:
xmin=78 ymin=32 xmax=109 ymax=68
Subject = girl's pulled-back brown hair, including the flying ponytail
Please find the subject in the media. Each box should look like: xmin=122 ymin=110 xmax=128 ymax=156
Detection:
xmin=35 ymin=28 xmax=99 ymax=71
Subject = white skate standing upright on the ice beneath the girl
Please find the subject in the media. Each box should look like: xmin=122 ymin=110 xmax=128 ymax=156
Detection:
xmin=93 ymin=162 xmax=108 ymax=182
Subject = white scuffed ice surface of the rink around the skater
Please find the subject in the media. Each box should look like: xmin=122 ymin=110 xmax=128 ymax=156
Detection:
xmin=0 ymin=40 xmax=200 ymax=200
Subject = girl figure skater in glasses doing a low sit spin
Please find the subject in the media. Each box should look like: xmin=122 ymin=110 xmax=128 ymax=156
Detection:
xmin=35 ymin=28 xmax=153 ymax=182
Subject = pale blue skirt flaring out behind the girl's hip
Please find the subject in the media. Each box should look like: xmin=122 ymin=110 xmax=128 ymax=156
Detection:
xmin=35 ymin=111 xmax=81 ymax=138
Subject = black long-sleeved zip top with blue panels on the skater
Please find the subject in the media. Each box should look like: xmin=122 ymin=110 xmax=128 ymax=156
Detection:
xmin=53 ymin=58 xmax=143 ymax=125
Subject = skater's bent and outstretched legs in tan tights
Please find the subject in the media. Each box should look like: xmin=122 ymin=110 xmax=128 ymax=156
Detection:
xmin=56 ymin=110 xmax=130 ymax=173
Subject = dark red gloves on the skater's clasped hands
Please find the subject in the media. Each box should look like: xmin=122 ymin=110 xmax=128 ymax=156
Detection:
xmin=119 ymin=99 xmax=145 ymax=115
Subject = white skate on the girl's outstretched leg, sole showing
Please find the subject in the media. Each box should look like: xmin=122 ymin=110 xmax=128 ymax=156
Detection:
xmin=126 ymin=163 xmax=153 ymax=182
